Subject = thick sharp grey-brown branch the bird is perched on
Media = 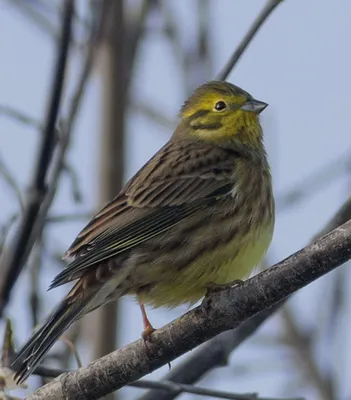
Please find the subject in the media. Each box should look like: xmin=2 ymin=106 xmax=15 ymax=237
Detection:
xmin=28 ymin=221 xmax=351 ymax=400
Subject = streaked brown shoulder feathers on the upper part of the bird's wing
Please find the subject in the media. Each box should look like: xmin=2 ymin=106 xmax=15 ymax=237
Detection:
xmin=125 ymin=141 xmax=237 ymax=207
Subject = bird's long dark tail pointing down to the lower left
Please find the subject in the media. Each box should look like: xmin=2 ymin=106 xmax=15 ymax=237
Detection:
xmin=12 ymin=280 xmax=101 ymax=383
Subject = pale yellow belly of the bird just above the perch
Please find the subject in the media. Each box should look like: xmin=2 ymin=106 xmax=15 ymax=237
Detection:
xmin=136 ymin=220 xmax=273 ymax=307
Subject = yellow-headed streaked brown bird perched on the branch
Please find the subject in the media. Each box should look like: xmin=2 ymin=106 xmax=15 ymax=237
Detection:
xmin=13 ymin=81 xmax=274 ymax=383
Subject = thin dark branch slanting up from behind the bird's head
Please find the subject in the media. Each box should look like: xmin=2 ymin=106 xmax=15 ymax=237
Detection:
xmin=216 ymin=0 xmax=283 ymax=81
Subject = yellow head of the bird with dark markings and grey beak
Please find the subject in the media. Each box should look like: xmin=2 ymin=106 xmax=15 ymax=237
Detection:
xmin=174 ymin=81 xmax=268 ymax=146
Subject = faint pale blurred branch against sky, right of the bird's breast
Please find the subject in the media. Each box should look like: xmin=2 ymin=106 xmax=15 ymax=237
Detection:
xmin=276 ymin=152 xmax=351 ymax=212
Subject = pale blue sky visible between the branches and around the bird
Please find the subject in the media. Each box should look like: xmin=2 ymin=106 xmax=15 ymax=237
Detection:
xmin=0 ymin=0 xmax=351 ymax=400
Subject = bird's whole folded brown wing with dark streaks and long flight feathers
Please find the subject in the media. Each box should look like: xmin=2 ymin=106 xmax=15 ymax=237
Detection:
xmin=51 ymin=141 xmax=237 ymax=288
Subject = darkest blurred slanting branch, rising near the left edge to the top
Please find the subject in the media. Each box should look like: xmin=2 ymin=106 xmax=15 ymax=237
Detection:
xmin=0 ymin=0 xmax=74 ymax=315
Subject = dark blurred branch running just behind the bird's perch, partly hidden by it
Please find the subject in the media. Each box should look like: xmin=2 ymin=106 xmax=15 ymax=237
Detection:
xmin=140 ymin=198 xmax=351 ymax=400
